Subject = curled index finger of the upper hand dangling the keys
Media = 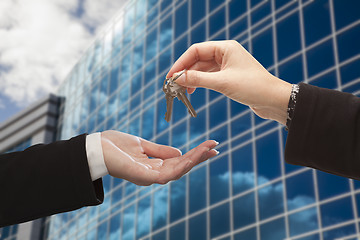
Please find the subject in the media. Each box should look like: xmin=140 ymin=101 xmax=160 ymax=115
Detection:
xmin=166 ymin=41 xmax=223 ymax=78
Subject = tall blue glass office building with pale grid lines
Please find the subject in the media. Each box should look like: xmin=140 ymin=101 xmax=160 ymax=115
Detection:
xmin=48 ymin=0 xmax=360 ymax=240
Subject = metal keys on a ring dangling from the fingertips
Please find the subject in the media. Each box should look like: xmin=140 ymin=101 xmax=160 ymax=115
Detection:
xmin=163 ymin=70 xmax=197 ymax=122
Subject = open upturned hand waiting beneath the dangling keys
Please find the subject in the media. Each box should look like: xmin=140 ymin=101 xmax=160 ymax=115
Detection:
xmin=101 ymin=131 xmax=218 ymax=186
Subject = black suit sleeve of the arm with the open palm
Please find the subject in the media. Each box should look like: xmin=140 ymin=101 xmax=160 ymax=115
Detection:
xmin=0 ymin=135 xmax=104 ymax=226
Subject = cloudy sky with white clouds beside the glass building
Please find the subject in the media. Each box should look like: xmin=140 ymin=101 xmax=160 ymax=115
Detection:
xmin=0 ymin=0 xmax=126 ymax=124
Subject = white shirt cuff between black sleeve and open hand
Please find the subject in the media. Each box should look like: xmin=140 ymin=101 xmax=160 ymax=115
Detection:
xmin=86 ymin=132 xmax=109 ymax=181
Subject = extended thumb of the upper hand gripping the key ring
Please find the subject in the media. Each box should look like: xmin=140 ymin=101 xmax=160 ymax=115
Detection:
xmin=174 ymin=70 xmax=221 ymax=91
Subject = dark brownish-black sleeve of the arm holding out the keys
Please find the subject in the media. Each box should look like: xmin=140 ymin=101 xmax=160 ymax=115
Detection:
xmin=285 ymin=83 xmax=360 ymax=180
